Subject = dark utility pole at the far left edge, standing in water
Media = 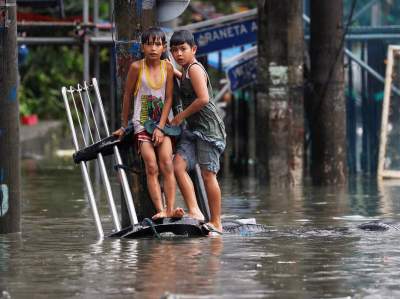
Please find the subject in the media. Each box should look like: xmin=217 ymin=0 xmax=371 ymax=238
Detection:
xmin=0 ymin=0 xmax=21 ymax=234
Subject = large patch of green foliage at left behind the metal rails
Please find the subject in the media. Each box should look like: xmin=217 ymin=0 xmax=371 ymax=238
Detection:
xmin=19 ymin=46 xmax=83 ymax=118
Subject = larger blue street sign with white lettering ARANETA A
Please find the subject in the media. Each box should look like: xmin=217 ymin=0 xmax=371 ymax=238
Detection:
xmin=193 ymin=19 xmax=257 ymax=55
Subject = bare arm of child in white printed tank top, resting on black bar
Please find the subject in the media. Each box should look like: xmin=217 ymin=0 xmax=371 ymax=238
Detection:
xmin=113 ymin=62 xmax=139 ymax=136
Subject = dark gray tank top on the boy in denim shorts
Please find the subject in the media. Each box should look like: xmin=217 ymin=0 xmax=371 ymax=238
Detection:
xmin=180 ymin=61 xmax=226 ymax=143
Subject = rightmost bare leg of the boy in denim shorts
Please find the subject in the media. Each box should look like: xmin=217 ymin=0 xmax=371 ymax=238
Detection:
xmin=201 ymin=169 xmax=222 ymax=231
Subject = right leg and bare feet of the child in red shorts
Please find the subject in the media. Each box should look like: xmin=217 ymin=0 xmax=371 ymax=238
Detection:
xmin=153 ymin=136 xmax=184 ymax=219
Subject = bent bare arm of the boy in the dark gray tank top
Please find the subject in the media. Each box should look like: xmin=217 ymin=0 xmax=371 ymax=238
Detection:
xmin=172 ymin=64 xmax=210 ymax=125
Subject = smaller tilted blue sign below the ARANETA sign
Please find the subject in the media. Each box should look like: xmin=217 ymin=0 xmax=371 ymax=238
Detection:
xmin=226 ymin=56 xmax=257 ymax=91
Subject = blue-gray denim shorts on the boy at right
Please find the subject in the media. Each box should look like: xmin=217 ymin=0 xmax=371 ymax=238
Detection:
xmin=176 ymin=130 xmax=223 ymax=173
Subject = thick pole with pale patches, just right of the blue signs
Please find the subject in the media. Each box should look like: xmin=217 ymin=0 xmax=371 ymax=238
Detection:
xmin=256 ymin=0 xmax=304 ymax=186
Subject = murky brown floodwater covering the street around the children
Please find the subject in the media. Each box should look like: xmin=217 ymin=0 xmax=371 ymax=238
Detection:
xmin=0 ymin=160 xmax=400 ymax=298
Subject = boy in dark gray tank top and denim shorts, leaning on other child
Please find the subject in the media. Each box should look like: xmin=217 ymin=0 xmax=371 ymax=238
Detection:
xmin=170 ymin=30 xmax=226 ymax=234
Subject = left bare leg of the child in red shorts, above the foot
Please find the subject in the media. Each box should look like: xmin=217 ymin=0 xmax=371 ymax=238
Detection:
xmin=140 ymin=142 xmax=163 ymax=213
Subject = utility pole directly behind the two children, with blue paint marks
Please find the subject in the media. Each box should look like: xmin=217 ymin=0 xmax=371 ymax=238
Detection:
xmin=114 ymin=0 xmax=156 ymax=227
